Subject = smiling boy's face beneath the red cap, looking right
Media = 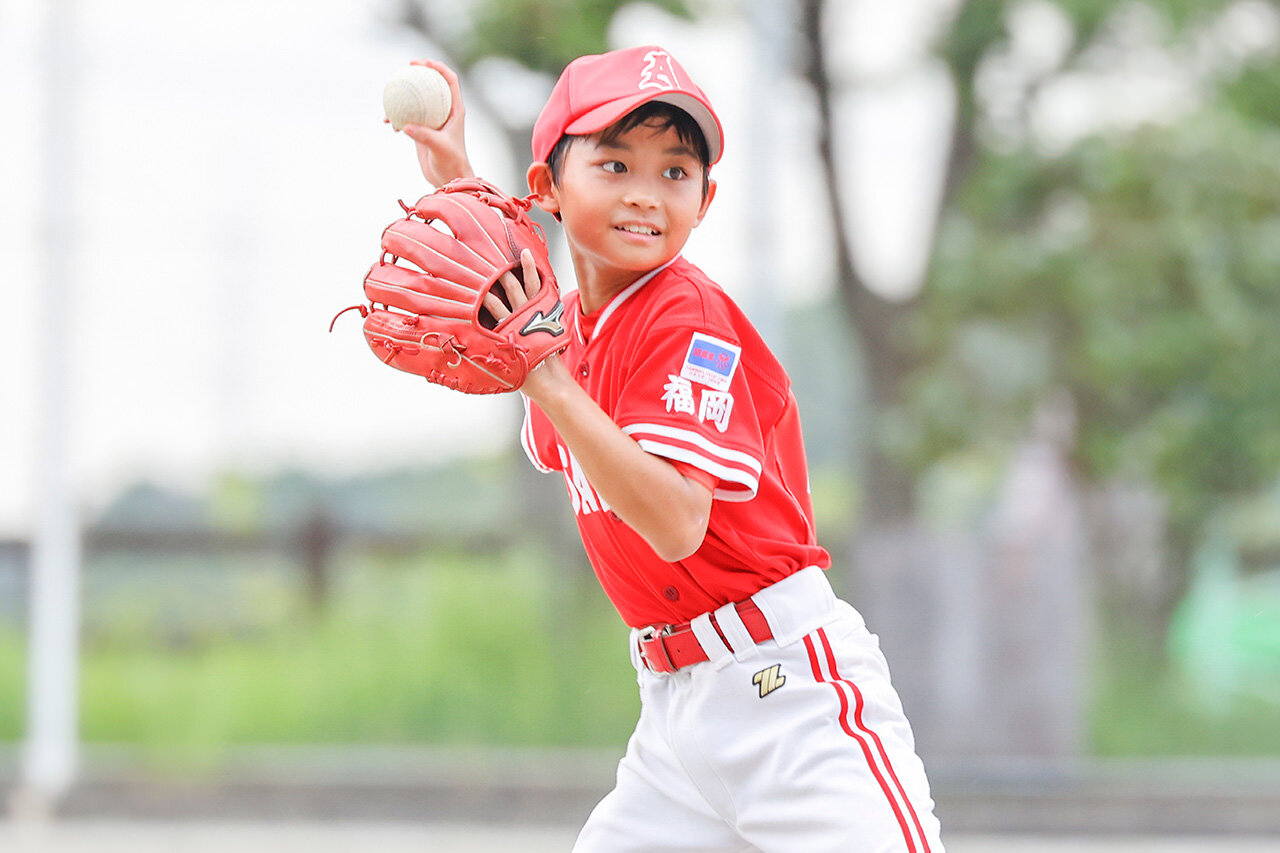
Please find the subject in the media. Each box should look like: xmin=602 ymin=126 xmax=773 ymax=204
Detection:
xmin=541 ymin=117 xmax=716 ymax=288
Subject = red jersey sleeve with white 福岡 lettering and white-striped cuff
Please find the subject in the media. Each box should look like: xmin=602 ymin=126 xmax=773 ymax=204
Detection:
xmin=613 ymin=320 xmax=764 ymax=501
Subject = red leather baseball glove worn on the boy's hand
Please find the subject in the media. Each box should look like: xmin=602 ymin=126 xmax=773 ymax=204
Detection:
xmin=361 ymin=179 xmax=568 ymax=394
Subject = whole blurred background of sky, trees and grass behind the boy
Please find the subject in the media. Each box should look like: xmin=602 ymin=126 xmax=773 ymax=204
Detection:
xmin=0 ymin=0 xmax=1280 ymax=849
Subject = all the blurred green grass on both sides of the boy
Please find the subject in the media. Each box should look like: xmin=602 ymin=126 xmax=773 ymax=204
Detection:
xmin=0 ymin=553 xmax=1280 ymax=768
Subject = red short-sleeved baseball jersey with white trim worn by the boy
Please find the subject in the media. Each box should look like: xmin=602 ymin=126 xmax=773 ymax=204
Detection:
xmin=521 ymin=257 xmax=831 ymax=628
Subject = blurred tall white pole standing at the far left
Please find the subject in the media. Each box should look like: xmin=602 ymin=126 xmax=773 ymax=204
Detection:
xmin=19 ymin=0 xmax=81 ymax=813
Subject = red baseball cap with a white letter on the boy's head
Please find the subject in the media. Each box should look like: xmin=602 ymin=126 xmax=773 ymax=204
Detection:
xmin=532 ymin=45 xmax=724 ymax=163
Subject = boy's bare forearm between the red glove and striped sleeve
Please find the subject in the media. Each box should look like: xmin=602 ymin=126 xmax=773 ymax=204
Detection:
xmin=521 ymin=359 xmax=712 ymax=562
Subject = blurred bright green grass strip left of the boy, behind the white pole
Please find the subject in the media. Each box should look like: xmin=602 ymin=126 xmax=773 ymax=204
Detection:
xmin=0 ymin=556 xmax=639 ymax=763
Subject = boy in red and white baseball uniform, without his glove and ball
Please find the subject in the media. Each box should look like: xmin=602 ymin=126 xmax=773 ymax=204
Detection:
xmin=406 ymin=46 xmax=942 ymax=853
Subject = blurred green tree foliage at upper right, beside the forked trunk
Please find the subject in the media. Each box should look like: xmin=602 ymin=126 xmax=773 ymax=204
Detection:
xmin=819 ymin=0 xmax=1280 ymax=653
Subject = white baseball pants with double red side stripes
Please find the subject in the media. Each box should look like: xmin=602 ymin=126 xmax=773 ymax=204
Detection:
xmin=573 ymin=567 xmax=943 ymax=853
